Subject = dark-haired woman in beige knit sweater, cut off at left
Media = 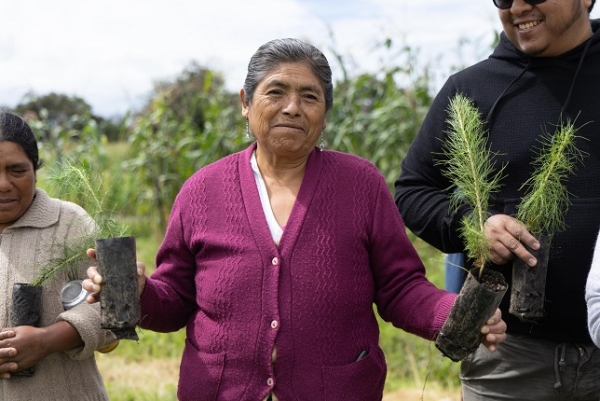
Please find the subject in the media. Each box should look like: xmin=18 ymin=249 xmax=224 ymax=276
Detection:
xmin=0 ymin=111 xmax=115 ymax=401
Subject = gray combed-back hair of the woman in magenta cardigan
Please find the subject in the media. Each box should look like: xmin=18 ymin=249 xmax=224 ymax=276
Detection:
xmin=244 ymin=38 xmax=333 ymax=111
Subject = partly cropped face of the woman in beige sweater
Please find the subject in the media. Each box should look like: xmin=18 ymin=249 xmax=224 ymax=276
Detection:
xmin=0 ymin=141 xmax=35 ymax=232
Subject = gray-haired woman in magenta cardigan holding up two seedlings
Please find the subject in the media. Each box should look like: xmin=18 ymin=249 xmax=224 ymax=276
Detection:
xmin=85 ymin=39 xmax=505 ymax=401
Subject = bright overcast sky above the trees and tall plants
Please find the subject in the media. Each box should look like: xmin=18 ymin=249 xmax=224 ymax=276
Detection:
xmin=0 ymin=0 xmax=598 ymax=117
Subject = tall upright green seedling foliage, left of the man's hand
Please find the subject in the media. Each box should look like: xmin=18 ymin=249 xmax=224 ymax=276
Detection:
xmin=439 ymin=94 xmax=503 ymax=273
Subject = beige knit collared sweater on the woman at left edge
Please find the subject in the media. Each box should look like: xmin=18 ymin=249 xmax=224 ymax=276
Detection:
xmin=0 ymin=189 xmax=115 ymax=401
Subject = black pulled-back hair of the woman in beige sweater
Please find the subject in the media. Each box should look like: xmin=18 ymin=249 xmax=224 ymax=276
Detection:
xmin=0 ymin=110 xmax=42 ymax=171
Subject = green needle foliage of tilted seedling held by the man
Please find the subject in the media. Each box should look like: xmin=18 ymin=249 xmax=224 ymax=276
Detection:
xmin=516 ymin=117 xmax=585 ymax=237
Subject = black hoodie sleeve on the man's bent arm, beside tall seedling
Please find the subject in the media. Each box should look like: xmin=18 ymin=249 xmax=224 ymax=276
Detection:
xmin=395 ymin=78 xmax=468 ymax=253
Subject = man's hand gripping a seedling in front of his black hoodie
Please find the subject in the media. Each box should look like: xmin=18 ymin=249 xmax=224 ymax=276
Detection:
xmin=484 ymin=214 xmax=540 ymax=266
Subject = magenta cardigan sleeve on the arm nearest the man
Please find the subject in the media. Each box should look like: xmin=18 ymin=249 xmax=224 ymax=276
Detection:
xmin=370 ymin=171 xmax=456 ymax=340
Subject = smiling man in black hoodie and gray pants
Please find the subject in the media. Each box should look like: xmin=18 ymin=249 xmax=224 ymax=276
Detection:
xmin=395 ymin=0 xmax=600 ymax=401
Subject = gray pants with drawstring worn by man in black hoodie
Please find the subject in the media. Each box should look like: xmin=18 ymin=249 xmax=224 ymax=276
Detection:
xmin=460 ymin=335 xmax=600 ymax=401
